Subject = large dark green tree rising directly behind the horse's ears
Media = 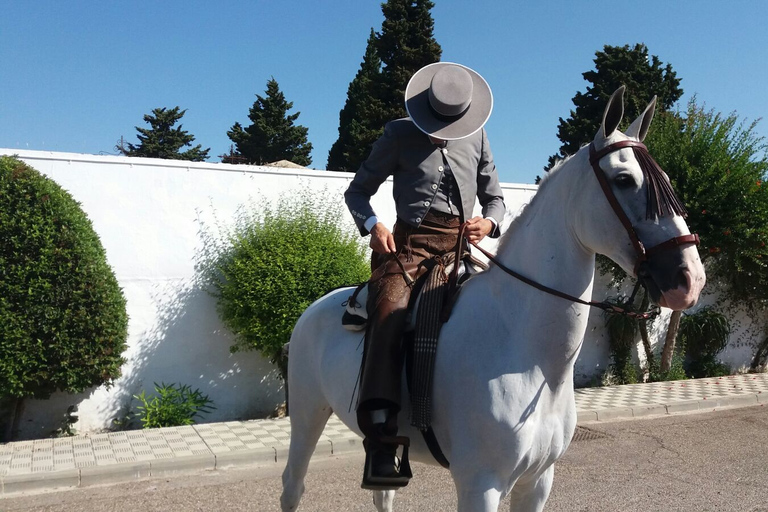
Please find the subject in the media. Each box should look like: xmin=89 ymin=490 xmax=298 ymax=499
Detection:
xmin=544 ymin=44 xmax=683 ymax=171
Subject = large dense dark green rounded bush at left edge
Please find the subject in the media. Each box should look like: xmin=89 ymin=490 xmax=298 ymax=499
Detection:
xmin=0 ymin=157 xmax=128 ymax=398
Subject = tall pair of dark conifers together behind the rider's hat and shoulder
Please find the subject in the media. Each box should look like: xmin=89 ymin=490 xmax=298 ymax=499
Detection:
xmin=328 ymin=0 xmax=442 ymax=172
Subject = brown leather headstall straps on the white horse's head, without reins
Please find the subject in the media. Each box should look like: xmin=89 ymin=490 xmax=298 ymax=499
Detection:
xmin=589 ymin=140 xmax=699 ymax=275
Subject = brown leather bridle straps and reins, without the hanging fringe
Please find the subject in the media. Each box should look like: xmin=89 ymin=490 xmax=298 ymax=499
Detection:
xmin=451 ymin=140 xmax=699 ymax=320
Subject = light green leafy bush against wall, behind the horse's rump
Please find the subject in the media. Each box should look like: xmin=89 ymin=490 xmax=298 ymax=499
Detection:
xmin=201 ymin=192 xmax=370 ymax=377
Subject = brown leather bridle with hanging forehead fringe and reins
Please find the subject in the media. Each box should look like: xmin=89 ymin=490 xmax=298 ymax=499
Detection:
xmin=450 ymin=140 xmax=699 ymax=320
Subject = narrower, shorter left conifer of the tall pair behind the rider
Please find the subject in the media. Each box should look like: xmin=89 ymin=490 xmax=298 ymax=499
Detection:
xmin=327 ymin=29 xmax=382 ymax=172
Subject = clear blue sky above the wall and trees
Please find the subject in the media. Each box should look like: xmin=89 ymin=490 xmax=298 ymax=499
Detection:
xmin=0 ymin=0 xmax=768 ymax=183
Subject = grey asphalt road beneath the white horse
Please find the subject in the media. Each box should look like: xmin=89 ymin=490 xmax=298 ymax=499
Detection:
xmin=0 ymin=407 xmax=768 ymax=512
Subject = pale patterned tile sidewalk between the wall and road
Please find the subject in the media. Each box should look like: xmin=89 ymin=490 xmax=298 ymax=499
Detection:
xmin=0 ymin=374 xmax=768 ymax=496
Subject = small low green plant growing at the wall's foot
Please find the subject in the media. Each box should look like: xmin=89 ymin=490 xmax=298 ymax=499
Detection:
xmin=134 ymin=382 xmax=216 ymax=428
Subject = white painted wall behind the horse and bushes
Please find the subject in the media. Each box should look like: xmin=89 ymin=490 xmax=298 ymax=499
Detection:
xmin=0 ymin=149 xmax=751 ymax=437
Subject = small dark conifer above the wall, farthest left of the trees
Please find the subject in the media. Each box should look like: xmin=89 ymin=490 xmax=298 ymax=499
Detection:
xmin=115 ymin=107 xmax=210 ymax=162
